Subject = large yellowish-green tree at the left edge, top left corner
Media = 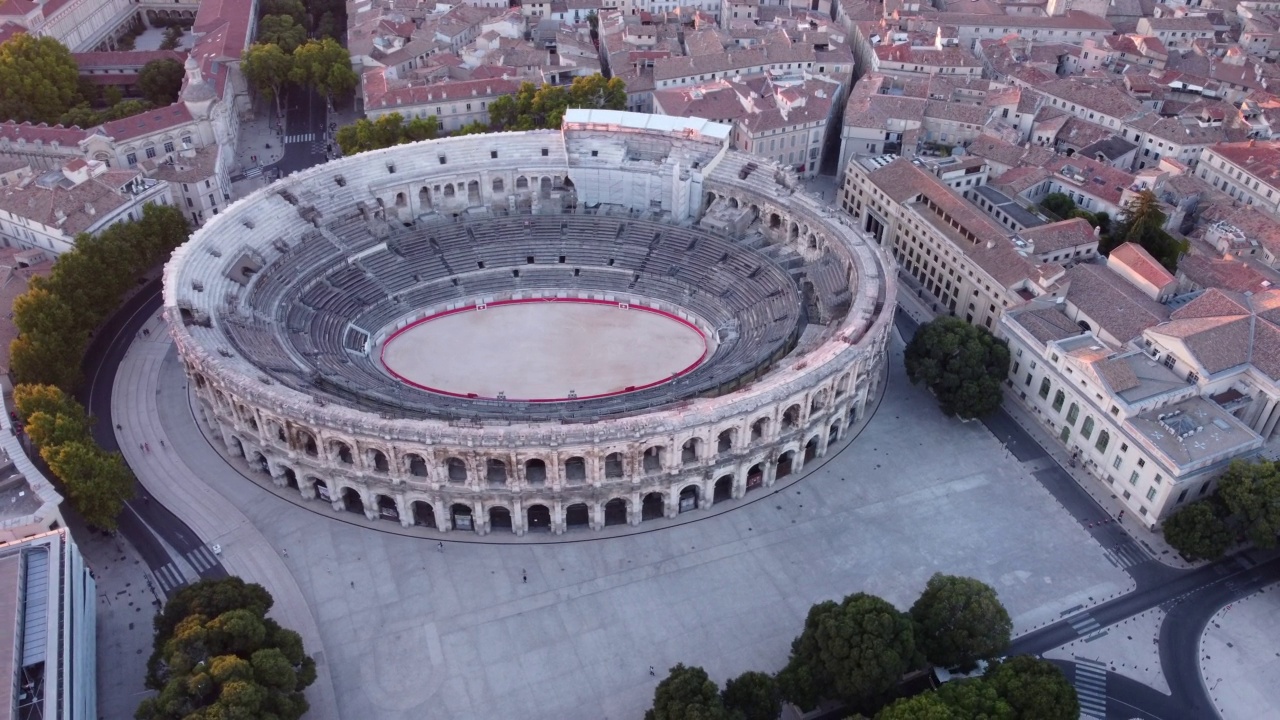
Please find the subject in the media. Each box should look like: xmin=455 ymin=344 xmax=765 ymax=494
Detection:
xmin=0 ymin=33 xmax=79 ymax=124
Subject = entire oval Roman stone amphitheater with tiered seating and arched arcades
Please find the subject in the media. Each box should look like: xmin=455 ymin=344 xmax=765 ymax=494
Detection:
xmin=164 ymin=110 xmax=895 ymax=536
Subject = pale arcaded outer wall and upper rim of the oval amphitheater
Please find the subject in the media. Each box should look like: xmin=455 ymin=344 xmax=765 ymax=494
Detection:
xmin=165 ymin=110 xmax=895 ymax=534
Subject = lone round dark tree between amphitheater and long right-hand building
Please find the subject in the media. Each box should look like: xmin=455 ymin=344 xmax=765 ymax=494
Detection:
xmin=905 ymin=316 xmax=1009 ymax=419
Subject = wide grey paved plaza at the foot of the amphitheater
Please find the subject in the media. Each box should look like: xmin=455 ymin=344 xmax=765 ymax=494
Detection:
xmin=122 ymin=326 xmax=1132 ymax=720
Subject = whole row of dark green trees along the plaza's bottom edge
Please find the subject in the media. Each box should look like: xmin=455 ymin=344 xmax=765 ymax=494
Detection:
xmin=645 ymin=574 xmax=1079 ymax=720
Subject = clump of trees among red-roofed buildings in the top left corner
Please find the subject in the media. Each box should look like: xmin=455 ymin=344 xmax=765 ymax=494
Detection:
xmin=0 ymin=29 xmax=184 ymax=128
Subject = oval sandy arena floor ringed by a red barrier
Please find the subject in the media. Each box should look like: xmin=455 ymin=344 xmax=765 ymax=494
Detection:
xmin=381 ymin=300 xmax=707 ymax=402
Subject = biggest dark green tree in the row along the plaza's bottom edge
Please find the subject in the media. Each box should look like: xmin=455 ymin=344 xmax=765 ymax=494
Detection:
xmin=778 ymin=593 xmax=919 ymax=710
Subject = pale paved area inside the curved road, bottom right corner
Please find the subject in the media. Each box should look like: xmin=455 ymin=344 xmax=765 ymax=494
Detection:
xmin=1199 ymin=584 xmax=1280 ymax=720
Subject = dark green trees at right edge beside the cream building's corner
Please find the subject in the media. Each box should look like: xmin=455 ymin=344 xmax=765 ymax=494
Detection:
xmin=1164 ymin=460 xmax=1280 ymax=560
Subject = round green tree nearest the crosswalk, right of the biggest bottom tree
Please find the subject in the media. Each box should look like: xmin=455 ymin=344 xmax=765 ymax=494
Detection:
xmin=910 ymin=573 xmax=1014 ymax=669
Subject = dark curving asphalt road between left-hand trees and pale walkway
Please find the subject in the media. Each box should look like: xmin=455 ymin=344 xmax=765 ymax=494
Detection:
xmin=79 ymin=279 xmax=227 ymax=586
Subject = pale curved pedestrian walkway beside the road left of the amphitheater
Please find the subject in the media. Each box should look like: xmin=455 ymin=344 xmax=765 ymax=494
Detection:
xmin=111 ymin=319 xmax=338 ymax=720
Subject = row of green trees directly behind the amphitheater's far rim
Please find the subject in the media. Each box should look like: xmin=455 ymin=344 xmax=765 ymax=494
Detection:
xmin=335 ymin=73 xmax=627 ymax=155
